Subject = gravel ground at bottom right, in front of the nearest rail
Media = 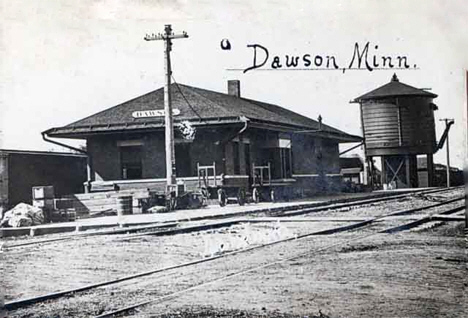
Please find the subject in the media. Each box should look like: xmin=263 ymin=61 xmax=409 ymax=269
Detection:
xmin=133 ymin=223 xmax=468 ymax=318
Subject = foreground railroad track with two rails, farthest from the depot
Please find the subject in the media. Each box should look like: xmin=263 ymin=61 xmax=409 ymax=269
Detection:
xmin=5 ymin=189 xmax=465 ymax=317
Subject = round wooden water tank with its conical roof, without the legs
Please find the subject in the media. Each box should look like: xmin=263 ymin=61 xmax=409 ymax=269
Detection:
xmin=355 ymin=75 xmax=437 ymax=156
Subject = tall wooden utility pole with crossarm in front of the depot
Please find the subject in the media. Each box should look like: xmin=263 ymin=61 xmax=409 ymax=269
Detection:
xmin=144 ymin=24 xmax=188 ymax=191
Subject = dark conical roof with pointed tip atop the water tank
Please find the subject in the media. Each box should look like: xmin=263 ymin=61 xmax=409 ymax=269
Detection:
xmin=354 ymin=74 xmax=437 ymax=102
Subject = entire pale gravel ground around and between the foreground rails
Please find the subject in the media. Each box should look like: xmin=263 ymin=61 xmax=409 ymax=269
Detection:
xmin=0 ymin=191 xmax=466 ymax=318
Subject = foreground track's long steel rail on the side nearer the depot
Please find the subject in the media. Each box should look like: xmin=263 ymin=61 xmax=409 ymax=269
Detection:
xmin=4 ymin=196 xmax=464 ymax=310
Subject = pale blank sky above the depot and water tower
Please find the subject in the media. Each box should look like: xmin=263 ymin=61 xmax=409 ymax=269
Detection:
xmin=0 ymin=0 xmax=468 ymax=168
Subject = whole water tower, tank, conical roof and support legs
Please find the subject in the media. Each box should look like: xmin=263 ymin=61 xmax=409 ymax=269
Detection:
xmin=353 ymin=74 xmax=437 ymax=189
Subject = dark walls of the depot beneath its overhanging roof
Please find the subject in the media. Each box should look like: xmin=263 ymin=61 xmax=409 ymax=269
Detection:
xmin=87 ymin=127 xmax=340 ymax=194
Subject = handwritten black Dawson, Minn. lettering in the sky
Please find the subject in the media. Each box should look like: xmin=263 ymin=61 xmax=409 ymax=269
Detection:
xmin=231 ymin=42 xmax=417 ymax=73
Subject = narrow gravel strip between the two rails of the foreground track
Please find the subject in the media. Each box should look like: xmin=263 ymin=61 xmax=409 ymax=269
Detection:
xmin=6 ymin=232 xmax=352 ymax=317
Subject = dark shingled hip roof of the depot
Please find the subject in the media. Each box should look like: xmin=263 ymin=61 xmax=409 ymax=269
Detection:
xmin=44 ymin=84 xmax=362 ymax=142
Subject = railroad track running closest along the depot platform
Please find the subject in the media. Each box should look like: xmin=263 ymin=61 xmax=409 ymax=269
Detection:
xmin=3 ymin=187 xmax=459 ymax=250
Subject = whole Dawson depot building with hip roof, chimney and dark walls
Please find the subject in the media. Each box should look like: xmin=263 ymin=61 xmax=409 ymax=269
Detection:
xmin=43 ymin=81 xmax=362 ymax=196
